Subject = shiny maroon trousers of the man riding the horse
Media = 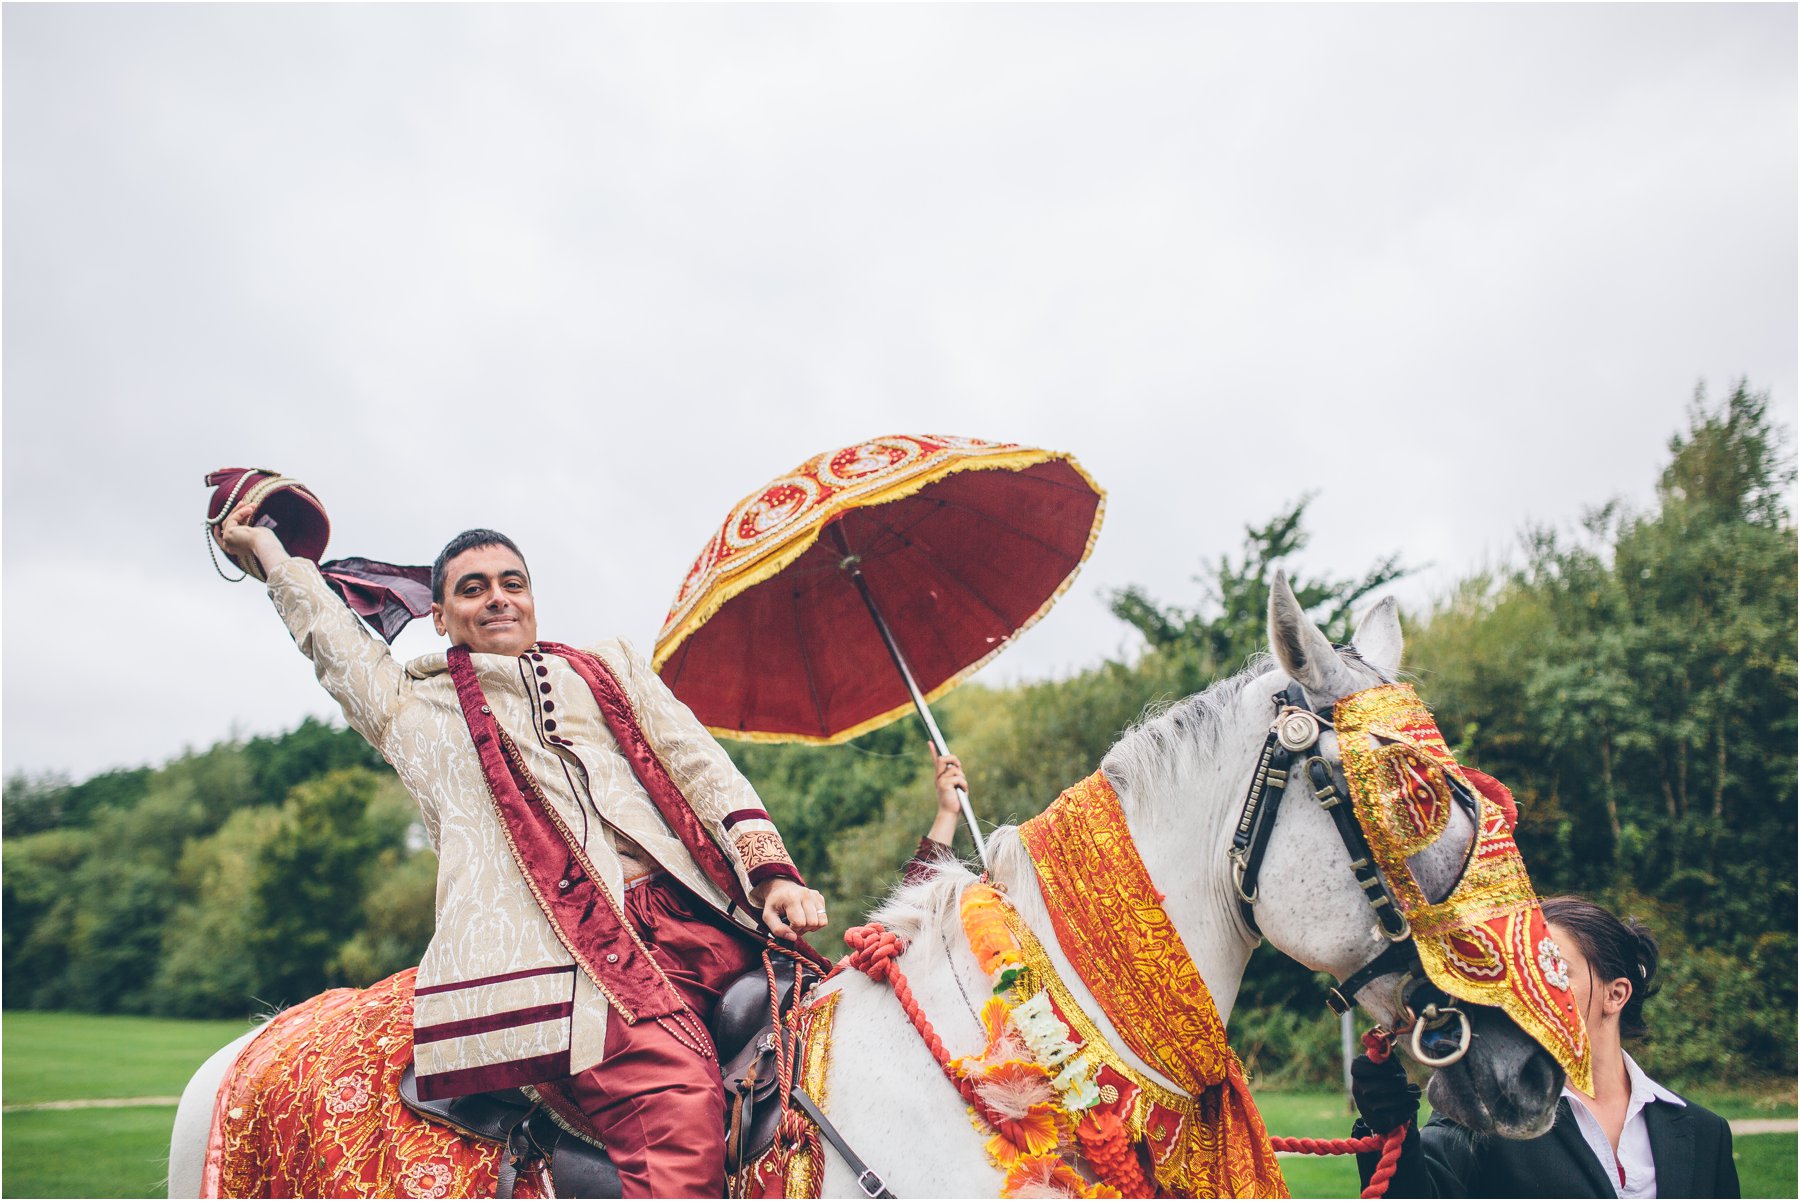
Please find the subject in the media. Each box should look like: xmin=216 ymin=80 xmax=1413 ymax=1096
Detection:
xmin=567 ymin=875 xmax=761 ymax=1197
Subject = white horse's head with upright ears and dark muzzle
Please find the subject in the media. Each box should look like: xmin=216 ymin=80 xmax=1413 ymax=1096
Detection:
xmin=1231 ymin=576 xmax=1579 ymax=1138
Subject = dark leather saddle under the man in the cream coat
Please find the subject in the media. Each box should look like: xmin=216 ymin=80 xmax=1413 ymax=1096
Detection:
xmin=400 ymin=956 xmax=819 ymax=1197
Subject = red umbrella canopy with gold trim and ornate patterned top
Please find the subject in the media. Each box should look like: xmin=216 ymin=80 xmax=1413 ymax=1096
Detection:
xmin=652 ymin=434 xmax=1105 ymax=742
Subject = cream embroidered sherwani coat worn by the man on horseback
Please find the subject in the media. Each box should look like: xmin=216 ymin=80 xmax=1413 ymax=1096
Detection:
xmin=268 ymin=558 xmax=799 ymax=1095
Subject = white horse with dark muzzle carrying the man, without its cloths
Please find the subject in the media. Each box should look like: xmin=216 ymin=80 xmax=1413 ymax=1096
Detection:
xmin=169 ymin=576 xmax=1562 ymax=1197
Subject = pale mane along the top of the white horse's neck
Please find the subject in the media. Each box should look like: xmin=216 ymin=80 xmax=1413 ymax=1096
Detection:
xmin=869 ymin=654 xmax=1273 ymax=940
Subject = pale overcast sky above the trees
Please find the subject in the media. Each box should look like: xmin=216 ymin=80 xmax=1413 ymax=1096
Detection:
xmin=4 ymin=4 xmax=1796 ymax=778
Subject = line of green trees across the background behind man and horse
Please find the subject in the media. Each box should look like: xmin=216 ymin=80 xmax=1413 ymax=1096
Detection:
xmin=0 ymin=385 xmax=1796 ymax=1082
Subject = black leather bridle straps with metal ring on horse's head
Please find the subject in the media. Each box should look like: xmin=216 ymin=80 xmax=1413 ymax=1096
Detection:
xmin=1226 ymin=682 xmax=1472 ymax=1068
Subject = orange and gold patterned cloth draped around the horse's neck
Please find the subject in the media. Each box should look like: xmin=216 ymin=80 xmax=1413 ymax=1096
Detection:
xmin=1015 ymin=772 xmax=1287 ymax=1197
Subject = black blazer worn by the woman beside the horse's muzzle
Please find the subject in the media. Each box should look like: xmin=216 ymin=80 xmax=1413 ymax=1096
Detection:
xmin=1355 ymin=1098 xmax=1739 ymax=1197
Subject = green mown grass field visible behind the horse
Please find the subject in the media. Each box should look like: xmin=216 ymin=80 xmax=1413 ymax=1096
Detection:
xmin=0 ymin=1012 xmax=1796 ymax=1197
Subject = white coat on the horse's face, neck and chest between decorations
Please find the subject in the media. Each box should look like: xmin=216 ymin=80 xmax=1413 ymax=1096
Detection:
xmin=824 ymin=580 xmax=1467 ymax=1197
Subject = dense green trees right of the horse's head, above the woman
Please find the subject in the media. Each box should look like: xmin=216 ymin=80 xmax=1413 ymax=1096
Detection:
xmin=1413 ymin=384 xmax=1796 ymax=1070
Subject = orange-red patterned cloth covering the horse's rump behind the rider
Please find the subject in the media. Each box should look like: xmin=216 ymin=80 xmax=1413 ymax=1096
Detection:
xmin=200 ymin=969 xmax=542 ymax=1197
